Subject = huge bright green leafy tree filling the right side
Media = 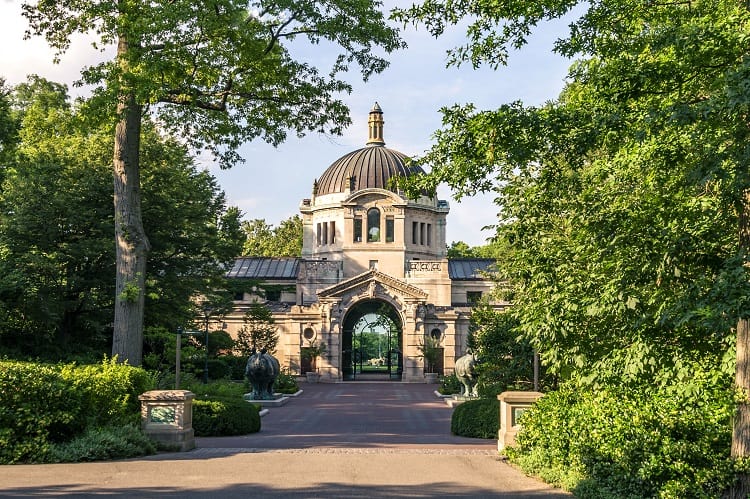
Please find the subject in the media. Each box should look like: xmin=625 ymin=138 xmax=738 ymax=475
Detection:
xmin=397 ymin=0 xmax=750 ymax=497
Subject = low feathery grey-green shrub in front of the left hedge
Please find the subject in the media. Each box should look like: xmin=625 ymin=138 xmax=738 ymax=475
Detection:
xmin=47 ymin=425 xmax=156 ymax=463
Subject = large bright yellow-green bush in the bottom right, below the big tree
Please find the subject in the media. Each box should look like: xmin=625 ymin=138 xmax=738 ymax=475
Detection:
xmin=507 ymin=373 xmax=734 ymax=498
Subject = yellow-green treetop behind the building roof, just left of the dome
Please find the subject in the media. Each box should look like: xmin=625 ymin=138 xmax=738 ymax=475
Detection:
xmin=242 ymin=215 xmax=302 ymax=257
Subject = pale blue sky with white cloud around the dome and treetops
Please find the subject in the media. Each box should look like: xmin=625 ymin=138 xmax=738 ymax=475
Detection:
xmin=0 ymin=0 xmax=571 ymax=246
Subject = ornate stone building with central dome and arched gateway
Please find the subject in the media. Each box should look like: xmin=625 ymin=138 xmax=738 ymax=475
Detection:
xmin=226 ymin=103 xmax=503 ymax=382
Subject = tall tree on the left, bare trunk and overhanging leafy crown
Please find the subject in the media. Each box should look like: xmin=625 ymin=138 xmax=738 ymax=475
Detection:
xmin=23 ymin=0 xmax=402 ymax=365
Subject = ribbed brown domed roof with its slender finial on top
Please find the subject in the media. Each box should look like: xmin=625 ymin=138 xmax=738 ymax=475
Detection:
xmin=316 ymin=102 xmax=424 ymax=196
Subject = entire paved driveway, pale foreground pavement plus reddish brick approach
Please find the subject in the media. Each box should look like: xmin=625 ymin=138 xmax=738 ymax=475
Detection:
xmin=0 ymin=383 xmax=570 ymax=499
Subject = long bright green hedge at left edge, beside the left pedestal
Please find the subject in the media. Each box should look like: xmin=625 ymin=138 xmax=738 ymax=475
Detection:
xmin=0 ymin=360 xmax=153 ymax=464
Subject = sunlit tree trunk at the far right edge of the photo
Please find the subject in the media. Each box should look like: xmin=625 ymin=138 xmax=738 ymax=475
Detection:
xmin=724 ymin=191 xmax=750 ymax=499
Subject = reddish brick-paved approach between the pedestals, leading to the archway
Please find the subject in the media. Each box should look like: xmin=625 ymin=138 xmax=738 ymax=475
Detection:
xmin=196 ymin=382 xmax=497 ymax=454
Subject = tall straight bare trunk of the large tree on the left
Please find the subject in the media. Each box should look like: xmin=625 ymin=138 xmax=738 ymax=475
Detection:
xmin=112 ymin=33 xmax=150 ymax=366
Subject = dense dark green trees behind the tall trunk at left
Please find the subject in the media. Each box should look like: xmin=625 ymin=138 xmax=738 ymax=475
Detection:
xmin=0 ymin=77 xmax=242 ymax=358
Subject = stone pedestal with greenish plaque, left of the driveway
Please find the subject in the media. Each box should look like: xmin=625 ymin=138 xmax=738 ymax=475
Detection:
xmin=138 ymin=390 xmax=195 ymax=452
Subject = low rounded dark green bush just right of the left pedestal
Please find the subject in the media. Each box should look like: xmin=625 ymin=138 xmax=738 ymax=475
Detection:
xmin=193 ymin=398 xmax=260 ymax=437
